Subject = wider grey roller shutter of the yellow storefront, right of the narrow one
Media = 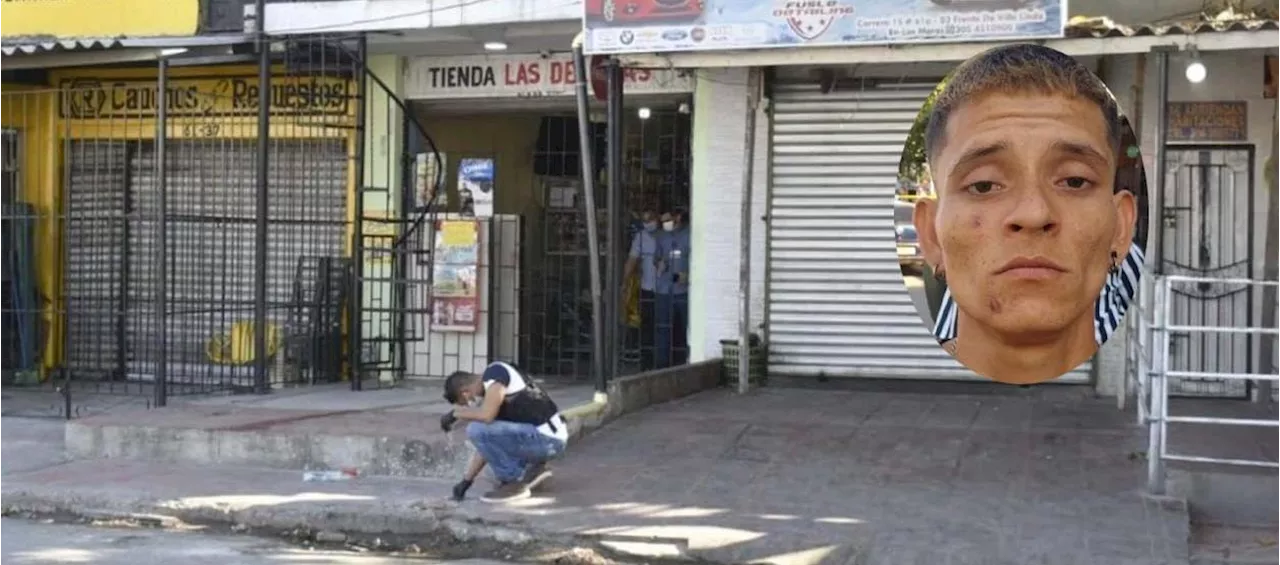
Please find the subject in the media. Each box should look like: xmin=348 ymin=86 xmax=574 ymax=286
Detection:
xmin=128 ymin=138 xmax=348 ymax=388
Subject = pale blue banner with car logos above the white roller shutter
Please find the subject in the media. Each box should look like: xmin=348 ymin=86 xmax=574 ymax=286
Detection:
xmin=582 ymin=0 xmax=1068 ymax=54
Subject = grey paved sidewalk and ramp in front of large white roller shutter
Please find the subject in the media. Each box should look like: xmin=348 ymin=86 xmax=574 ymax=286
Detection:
xmin=0 ymin=387 xmax=1188 ymax=565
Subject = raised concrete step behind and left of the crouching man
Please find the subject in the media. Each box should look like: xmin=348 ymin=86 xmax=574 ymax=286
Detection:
xmin=67 ymin=381 xmax=594 ymax=479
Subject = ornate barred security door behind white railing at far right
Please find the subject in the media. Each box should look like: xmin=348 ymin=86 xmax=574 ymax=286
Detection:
xmin=1161 ymin=146 xmax=1254 ymax=398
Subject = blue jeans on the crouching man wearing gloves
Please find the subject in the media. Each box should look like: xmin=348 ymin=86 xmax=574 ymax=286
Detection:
xmin=467 ymin=420 xmax=564 ymax=483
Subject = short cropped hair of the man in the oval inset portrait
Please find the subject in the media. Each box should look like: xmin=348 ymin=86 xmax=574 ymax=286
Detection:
xmin=924 ymin=44 xmax=1124 ymax=166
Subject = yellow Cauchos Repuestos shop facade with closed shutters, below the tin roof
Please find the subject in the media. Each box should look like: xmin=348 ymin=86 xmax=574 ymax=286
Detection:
xmin=0 ymin=65 xmax=355 ymax=379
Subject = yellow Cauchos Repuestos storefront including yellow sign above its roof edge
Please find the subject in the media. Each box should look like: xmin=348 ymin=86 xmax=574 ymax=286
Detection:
xmin=0 ymin=0 xmax=365 ymax=392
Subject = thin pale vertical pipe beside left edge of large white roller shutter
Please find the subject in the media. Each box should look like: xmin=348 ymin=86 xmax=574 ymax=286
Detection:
xmin=737 ymin=69 xmax=760 ymax=395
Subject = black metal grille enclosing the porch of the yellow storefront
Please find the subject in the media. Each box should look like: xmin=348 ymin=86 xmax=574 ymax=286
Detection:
xmin=0 ymin=37 xmax=378 ymax=416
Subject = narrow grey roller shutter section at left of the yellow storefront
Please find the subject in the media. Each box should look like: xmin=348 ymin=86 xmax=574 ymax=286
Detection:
xmin=63 ymin=140 xmax=129 ymax=381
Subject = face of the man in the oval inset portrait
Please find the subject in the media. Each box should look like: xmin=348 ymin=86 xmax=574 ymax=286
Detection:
xmin=915 ymin=95 xmax=1135 ymax=340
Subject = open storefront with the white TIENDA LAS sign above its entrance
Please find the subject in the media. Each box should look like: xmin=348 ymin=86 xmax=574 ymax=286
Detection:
xmin=257 ymin=1 xmax=696 ymax=379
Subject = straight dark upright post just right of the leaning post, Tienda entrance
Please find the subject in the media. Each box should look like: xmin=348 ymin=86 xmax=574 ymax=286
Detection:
xmin=605 ymin=59 xmax=626 ymax=375
